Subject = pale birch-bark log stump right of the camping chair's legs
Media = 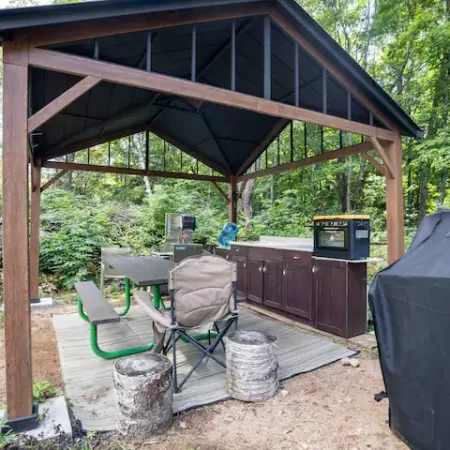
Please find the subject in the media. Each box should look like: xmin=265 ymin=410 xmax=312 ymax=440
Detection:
xmin=225 ymin=330 xmax=278 ymax=402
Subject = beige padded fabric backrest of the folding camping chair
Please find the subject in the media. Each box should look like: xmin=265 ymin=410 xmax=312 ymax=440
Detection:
xmin=169 ymin=254 xmax=236 ymax=328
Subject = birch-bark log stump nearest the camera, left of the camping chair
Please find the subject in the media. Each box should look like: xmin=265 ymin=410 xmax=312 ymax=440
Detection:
xmin=114 ymin=353 xmax=173 ymax=439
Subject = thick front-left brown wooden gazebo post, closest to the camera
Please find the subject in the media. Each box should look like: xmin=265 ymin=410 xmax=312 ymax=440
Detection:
xmin=3 ymin=40 xmax=33 ymax=419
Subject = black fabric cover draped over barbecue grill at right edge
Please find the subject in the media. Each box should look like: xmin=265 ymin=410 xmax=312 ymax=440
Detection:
xmin=369 ymin=211 xmax=450 ymax=450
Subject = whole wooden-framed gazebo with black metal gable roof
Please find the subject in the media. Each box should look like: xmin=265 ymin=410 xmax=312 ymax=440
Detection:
xmin=0 ymin=0 xmax=421 ymax=426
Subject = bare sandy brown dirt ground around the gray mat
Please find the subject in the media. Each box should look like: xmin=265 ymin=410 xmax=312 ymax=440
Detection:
xmin=0 ymin=309 xmax=407 ymax=450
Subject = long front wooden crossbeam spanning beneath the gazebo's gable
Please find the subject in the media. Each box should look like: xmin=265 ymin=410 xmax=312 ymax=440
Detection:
xmin=30 ymin=48 xmax=394 ymax=141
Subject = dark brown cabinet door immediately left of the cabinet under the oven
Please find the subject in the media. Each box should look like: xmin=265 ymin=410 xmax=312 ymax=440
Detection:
xmin=283 ymin=258 xmax=313 ymax=321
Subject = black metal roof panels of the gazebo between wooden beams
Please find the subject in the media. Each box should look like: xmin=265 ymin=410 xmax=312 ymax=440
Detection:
xmin=0 ymin=0 xmax=421 ymax=174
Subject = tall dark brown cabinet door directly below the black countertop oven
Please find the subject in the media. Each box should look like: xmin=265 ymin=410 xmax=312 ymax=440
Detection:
xmin=314 ymin=260 xmax=348 ymax=336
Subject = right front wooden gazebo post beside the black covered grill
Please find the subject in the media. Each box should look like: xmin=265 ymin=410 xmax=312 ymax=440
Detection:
xmin=386 ymin=133 xmax=405 ymax=264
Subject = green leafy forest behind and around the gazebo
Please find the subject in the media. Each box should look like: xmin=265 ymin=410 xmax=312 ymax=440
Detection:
xmin=2 ymin=0 xmax=450 ymax=290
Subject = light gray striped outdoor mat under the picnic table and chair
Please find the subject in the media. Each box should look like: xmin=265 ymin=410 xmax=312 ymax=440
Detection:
xmin=53 ymin=306 xmax=355 ymax=431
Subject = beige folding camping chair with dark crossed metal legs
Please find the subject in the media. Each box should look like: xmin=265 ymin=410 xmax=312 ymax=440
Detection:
xmin=145 ymin=254 xmax=238 ymax=392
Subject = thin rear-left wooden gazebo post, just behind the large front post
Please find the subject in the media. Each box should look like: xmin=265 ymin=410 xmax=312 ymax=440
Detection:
xmin=30 ymin=158 xmax=41 ymax=298
